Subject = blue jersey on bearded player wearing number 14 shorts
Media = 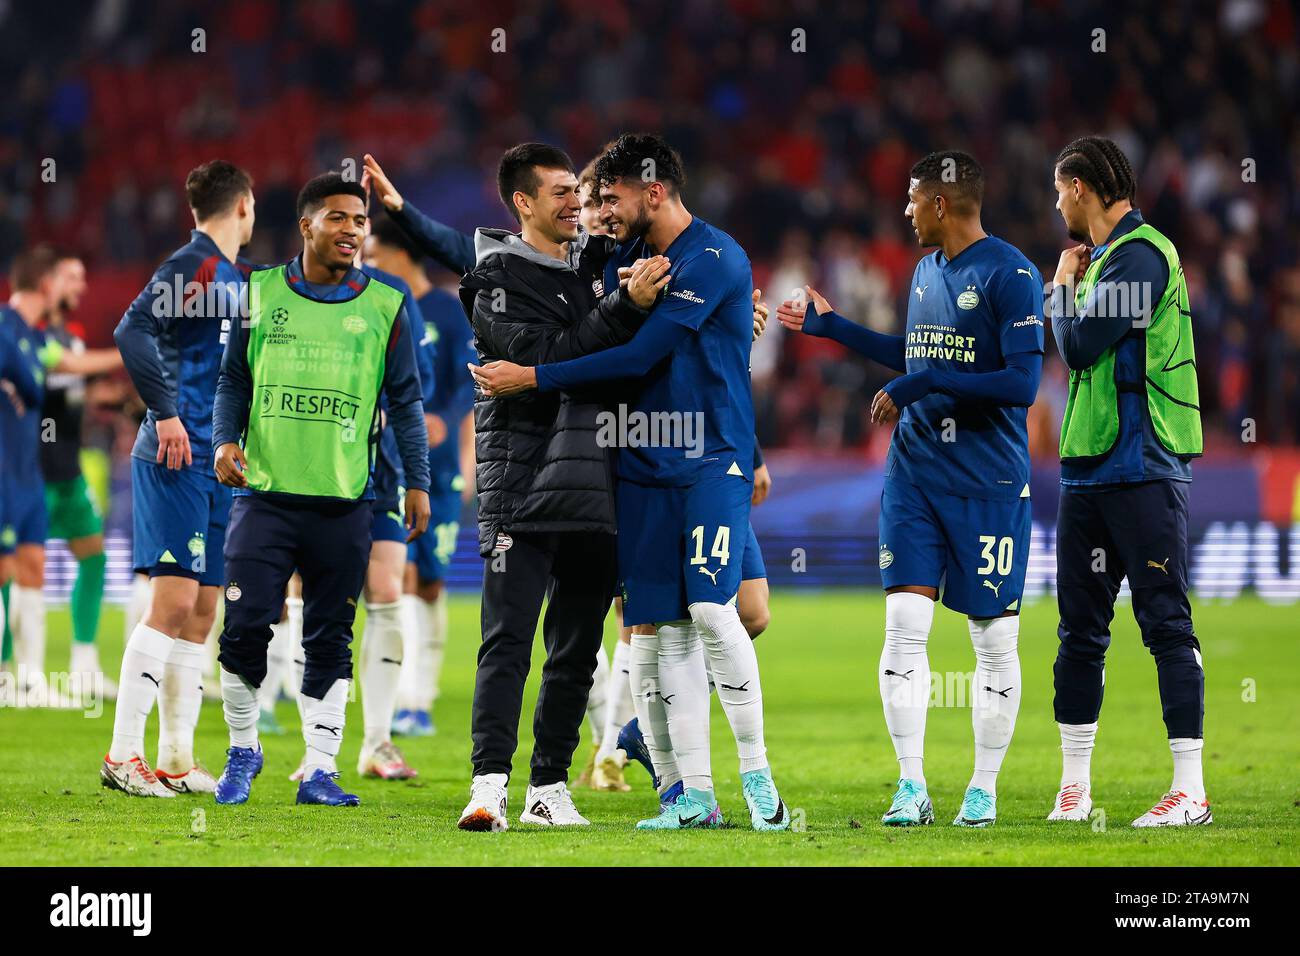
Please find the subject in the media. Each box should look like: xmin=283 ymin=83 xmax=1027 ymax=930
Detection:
xmin=605 ymin=217 xmax=754 ymax=486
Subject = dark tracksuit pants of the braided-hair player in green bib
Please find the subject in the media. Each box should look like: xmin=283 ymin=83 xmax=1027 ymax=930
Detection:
xmin=1054 ymin=480 xmax=1205 ymax=737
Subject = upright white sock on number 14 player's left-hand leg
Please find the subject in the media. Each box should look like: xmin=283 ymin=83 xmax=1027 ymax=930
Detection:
xmin=655 ymin=620 xmax=714 ymax=791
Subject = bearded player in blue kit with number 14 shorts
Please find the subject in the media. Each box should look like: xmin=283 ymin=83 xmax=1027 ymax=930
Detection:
xmin=472 ymin=134 xmax=789 ymax=830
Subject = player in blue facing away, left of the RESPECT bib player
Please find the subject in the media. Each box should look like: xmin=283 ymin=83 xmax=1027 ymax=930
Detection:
xmin=100 ymin=160 xmax=255 ymax=796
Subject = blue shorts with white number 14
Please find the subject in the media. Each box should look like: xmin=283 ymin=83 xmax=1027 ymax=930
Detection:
xmin=618 ymin=475 xmax=753 ymax=627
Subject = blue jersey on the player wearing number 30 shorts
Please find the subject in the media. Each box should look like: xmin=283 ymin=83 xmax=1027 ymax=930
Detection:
xmin=885 ymin=235 xmax=1044 ymax=499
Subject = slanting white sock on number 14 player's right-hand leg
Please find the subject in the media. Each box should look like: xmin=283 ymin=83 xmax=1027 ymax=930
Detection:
xmin=688 ymin=602 xmax=767 ymax=774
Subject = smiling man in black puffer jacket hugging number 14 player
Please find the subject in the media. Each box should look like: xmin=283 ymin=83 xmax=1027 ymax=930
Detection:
xmin=459 ymin=143 xmax=668 ymax=830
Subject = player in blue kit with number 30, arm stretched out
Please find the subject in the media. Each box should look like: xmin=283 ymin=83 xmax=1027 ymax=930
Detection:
xmin=777 ymin=151 xmax=1044 ymax=827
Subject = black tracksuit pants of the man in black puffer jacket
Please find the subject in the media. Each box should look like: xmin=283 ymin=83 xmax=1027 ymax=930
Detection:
xmin=472 ymin=532 xmax=616 ymax=787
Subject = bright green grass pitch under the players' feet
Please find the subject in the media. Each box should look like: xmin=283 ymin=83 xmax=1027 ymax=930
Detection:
xmin=0 ymin=592 xmax=1300 ymax=866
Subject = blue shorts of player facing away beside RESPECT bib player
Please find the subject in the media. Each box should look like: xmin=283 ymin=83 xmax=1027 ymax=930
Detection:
xmin=131 ymin=458 xmax=230 ymax=587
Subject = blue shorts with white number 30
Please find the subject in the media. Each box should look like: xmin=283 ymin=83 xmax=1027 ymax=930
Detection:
xmin=880 ymin=477 xmax=1030 ymax=618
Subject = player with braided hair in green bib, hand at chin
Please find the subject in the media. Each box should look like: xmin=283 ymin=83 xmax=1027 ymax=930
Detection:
xmin=1048 ymin=137 xmax=1212 ymax=827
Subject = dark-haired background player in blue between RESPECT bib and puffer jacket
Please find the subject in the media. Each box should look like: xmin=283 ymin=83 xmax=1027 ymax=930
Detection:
xmin=365 ymin=218 xmax=477 ymax=736
